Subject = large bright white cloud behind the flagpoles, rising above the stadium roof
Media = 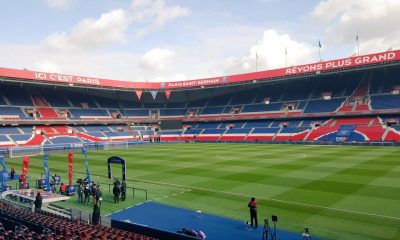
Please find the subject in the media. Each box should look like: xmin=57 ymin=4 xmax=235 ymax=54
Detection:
xmin=220 ymin=30 xmax=318 ymax=73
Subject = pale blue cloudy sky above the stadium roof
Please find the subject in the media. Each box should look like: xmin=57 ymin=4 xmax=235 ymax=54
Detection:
xmin=0 ymin=0 xmax=400 ymax=82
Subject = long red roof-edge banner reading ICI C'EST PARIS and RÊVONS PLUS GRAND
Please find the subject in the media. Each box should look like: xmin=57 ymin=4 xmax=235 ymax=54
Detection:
xmin=0 ymin=50 xmax=400 ymax=90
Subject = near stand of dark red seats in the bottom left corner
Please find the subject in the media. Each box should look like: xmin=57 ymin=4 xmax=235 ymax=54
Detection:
xmin=0 ymin=201 xmax=153 ymax=240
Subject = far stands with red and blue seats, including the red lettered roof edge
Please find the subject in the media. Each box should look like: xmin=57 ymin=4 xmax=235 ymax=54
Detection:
xmin=0 ymin=51 xmax=400 ymax=151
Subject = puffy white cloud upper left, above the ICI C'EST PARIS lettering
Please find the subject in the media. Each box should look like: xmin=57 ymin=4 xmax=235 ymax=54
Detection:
xmin=45 ymin=9 xmax=129 ymax=50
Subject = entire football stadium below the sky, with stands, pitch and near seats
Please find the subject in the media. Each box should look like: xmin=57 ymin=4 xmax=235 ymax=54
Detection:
xmin=0 ymin=51 xmax=400 ymax=239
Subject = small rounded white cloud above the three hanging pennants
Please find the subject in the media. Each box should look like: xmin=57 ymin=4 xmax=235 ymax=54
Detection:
xmin=141 ymin=48 xmax=175 ymax=71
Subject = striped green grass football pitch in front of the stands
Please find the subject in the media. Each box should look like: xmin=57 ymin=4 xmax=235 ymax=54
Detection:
xmin=8 ymin=143 xmax=400 ymax=239
